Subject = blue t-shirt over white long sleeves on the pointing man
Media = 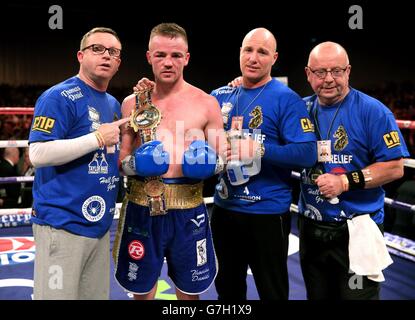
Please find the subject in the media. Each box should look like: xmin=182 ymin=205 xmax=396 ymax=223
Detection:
xmin=29 ymin=77 xmax=121 ymax=238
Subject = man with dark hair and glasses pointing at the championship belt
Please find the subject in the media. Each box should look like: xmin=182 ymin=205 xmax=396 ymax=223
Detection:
xmin=29 ymin=28 xmax=128 ymax=299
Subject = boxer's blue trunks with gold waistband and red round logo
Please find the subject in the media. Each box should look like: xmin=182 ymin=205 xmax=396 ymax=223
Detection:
xmin=113 ymin=178 xmax=217 ymax=295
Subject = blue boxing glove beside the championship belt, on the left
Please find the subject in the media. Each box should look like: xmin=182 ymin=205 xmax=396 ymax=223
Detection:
xmin=133 ymin=140 xmax=169 ymax=177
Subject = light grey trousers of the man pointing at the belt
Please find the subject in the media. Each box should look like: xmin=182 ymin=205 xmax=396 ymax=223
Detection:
xmin=33 ymin=224 xmax=110 ymax=300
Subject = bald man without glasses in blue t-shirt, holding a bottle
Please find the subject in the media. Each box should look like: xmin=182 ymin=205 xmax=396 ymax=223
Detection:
xmin=211 ymin=28 xmax=316 ymax=300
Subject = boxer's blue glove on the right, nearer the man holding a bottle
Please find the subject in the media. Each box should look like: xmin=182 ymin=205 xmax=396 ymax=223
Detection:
xmin=182 ymin=140 xmax=218 ymax=179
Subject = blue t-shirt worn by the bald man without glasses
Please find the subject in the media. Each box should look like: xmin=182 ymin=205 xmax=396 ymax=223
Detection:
xmin=211 ymin=79 xmax=315 ymax=214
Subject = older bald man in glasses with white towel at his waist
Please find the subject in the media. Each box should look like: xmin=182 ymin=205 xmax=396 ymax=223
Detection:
xmin=299 ymin=42 xmax=409 ymax=299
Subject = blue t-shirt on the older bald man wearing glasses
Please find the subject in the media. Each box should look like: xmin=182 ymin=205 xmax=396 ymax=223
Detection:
xmin=299 ymin=88 xmax=409 ymax=223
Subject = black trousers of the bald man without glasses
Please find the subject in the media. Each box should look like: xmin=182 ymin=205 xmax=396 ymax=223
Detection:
xmin=211 ymin=205 xmax=291 ymax=300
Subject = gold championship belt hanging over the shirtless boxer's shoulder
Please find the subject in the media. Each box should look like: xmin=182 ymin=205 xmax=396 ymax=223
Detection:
xmin=130 ymin=90 xmax=167 ymax=216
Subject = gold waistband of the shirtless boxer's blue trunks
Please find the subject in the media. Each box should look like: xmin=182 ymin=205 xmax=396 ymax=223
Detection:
xmin=127 ymin=180 xmax=203 ymax=209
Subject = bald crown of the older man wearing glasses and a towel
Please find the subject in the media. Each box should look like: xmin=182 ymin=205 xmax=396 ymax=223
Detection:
xmin=308 ymin=41 xmax=349 ymax=68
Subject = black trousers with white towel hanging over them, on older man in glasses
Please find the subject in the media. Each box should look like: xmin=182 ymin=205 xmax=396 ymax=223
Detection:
xmin=298 ymin=215 xmax=383 ymax=300
